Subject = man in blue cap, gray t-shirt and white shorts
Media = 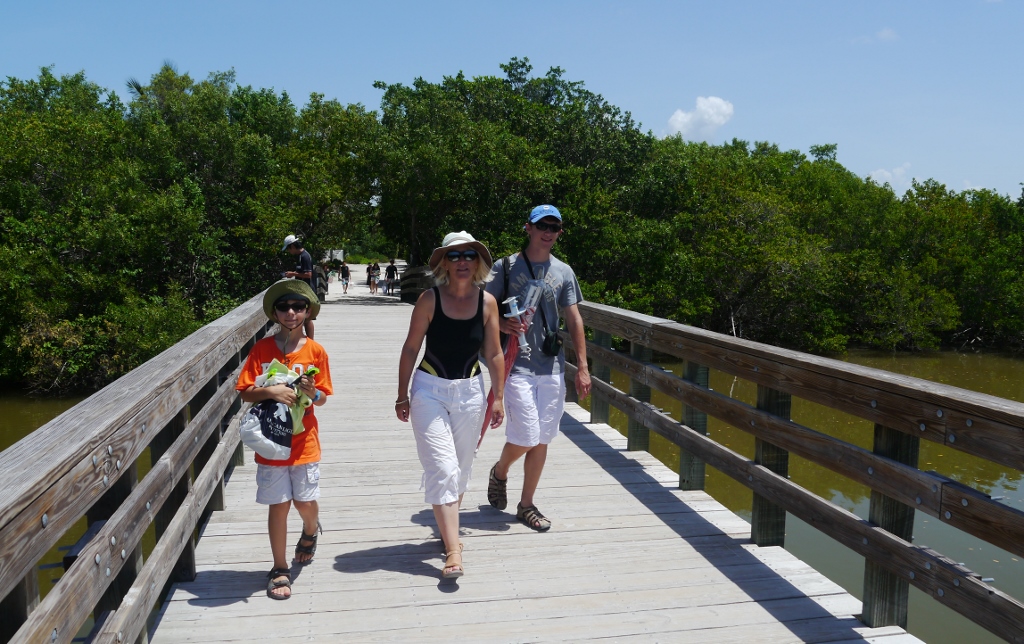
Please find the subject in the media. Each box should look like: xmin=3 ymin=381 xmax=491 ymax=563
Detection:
xmin=486 ymin=206 xmax=590 ymax=531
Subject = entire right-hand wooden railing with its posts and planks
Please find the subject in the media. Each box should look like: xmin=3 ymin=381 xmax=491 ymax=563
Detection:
xmin=562 ymin=303 xmax=1024 ymax=642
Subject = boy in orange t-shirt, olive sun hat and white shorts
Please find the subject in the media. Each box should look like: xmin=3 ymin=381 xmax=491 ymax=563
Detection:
xmin=236 ymin=280 xmax=334 ymax=599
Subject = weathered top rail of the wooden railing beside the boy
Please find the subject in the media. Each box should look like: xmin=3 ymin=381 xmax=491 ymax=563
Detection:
xmin=0 ymin=298 xmax=265 ymax=588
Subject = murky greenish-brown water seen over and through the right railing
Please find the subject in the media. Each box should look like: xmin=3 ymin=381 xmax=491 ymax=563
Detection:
xmin=581 ymin=352 xmax=1024 ymax=643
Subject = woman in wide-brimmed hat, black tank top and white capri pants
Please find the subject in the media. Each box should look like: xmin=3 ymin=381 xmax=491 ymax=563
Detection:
xmin=394 ymin=230 xmax=505 ymax=577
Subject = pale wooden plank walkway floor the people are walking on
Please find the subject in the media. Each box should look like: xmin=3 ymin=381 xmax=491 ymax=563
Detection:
xmin=151 ymin=274 xmax=918 ymax=644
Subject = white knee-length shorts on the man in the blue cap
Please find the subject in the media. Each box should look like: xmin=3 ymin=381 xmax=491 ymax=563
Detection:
xmin=505 ymin=374 xmax=565 ymax=447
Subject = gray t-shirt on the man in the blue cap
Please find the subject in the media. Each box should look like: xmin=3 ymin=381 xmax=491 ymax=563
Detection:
xmin=485 ymin=253 xmax=583 ymax=376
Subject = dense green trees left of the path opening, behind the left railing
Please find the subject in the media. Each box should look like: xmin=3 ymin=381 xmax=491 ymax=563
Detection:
xmin=0 ymin=66 xmax=377 ymax=392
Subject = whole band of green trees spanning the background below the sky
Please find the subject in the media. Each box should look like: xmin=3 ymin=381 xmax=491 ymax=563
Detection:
xmin=0 ymin=58 xmax=1024 ymax=391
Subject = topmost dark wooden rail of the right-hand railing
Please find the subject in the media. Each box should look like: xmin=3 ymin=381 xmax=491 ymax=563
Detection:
xmin=580 ymin=302 xmax=1024 ymax=469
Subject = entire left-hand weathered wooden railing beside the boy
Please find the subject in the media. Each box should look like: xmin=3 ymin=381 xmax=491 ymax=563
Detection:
xmin=0 ymin=294 xmax=269 ymax=644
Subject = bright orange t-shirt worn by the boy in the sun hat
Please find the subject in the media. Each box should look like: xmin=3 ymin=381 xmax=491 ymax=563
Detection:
xmin=234 ymin=336 xmax=334 ymax=465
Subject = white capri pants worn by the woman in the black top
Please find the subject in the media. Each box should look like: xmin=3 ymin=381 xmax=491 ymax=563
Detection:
xmin=409 ymin=370 xmax=487 ymax=505
